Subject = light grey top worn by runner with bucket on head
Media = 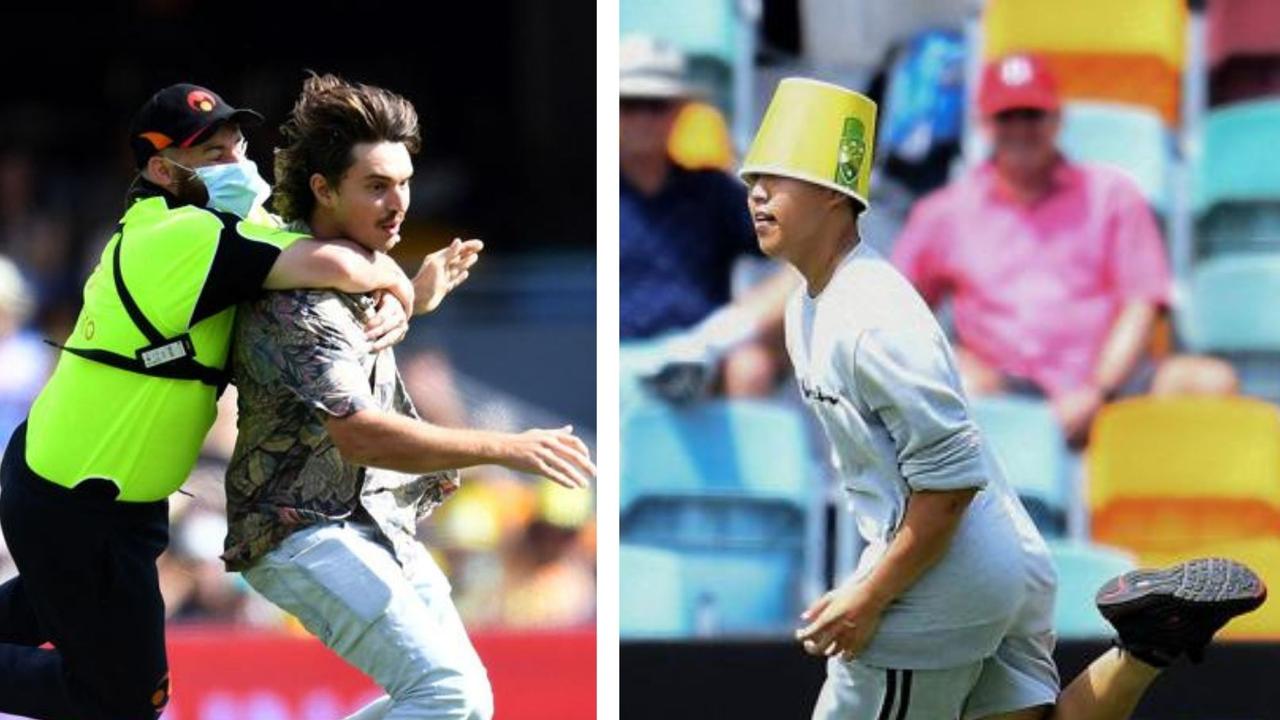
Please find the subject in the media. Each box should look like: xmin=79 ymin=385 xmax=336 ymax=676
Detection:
xmin=786 ymin=245 xmax=1056 ymax=669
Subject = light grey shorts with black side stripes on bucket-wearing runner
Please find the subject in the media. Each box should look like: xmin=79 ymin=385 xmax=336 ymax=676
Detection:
xmin=813 ymin=633 xmax=1059 ymax=720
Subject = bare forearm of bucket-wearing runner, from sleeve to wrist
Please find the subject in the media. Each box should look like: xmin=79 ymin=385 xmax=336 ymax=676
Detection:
xmin=864 ymin=489 xmax=977 ymax=607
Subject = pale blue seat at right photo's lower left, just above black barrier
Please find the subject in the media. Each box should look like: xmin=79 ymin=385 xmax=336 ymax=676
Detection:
xmin=618 ymin=543 xmax=694 ymax=638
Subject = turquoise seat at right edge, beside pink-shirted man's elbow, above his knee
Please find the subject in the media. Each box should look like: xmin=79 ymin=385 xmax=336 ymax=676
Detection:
xmin=1178 ymin=255 xmax=1280 ymax=354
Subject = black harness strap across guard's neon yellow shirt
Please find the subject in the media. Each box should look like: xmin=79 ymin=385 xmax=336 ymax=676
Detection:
xmin=45 ymin=223 xmax=228 ymax=395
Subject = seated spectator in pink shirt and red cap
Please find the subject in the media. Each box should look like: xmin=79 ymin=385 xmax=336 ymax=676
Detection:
xmin=892 ymin=55 xmax=1236 ymax=445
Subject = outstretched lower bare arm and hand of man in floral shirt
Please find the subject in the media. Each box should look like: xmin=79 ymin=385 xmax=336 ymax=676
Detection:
xmin=326 ymin=410 xmax=595 ymax=487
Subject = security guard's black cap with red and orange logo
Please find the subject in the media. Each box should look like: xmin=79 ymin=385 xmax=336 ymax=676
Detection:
xmin=129 ymin=82 xmax=262 ymax=168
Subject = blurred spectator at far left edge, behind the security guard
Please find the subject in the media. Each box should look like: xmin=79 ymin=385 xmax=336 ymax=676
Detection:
xmin=0 ymin=255 xmax=52 ymax=452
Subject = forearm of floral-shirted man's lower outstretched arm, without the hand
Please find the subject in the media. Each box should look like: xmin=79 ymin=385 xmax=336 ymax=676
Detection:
xmin=328 ymin=410 xmax=512 ymax=473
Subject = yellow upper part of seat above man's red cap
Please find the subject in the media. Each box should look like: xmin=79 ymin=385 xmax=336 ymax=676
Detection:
xmin=983 ymin=0 xmax=1187 ymax=69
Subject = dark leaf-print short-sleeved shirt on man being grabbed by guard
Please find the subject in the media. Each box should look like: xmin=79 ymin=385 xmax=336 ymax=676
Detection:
xmin=223 ymin=290 xmax=458 ymax=570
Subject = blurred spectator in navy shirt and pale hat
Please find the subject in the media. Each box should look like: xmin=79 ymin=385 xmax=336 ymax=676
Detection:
xmin=618 ymin=36 xmax=795 ymax=398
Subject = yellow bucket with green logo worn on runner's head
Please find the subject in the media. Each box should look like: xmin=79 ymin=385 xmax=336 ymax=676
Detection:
xmin=737 ymin=78 xmax=876 ymax=206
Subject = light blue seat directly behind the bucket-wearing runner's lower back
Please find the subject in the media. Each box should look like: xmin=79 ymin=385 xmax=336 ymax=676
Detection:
xmin=970 ymin=397 xmax=1070 ymax=537
